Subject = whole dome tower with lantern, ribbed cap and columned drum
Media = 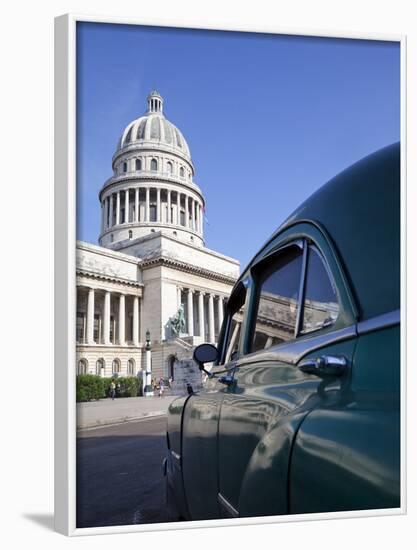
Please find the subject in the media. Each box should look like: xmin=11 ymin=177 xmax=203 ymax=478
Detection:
xmin=99 ymin=91 xmax=205 ymax=250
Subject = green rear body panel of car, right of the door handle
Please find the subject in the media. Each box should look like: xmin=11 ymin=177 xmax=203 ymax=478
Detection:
xmin=289 ymin=316 xmax=401 ymax=514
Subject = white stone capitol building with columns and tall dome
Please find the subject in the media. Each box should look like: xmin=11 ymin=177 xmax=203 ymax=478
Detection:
xmin=76 ymin=91 xmax=239 ymax=388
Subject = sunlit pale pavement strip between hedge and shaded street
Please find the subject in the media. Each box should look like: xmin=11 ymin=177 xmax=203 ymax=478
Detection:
xmin=77 ymin=395 xmax=176 ymax=429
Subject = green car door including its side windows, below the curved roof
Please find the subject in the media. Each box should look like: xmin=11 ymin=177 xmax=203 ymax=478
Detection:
xmin=217 ymin=224 xmax=355 ymax=517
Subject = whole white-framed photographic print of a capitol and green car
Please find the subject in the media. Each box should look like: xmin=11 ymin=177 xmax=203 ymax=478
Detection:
xmin=55 ymin=15 xmax=405 ymax=535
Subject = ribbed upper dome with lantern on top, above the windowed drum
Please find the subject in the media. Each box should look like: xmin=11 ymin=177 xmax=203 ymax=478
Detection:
xmin=117 ymin=91 xmax=191 ymax=160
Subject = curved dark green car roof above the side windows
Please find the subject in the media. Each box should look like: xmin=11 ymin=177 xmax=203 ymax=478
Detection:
xmin=240 ymin=143 xmax=401 ymax=319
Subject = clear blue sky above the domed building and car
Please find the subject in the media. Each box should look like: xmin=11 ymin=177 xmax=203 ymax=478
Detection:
xmin=77 ymin=23 xmax=400 ymax=268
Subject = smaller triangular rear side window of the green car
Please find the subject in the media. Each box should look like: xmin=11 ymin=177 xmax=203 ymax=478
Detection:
xmin=300 ymin=248 xmax=339 ymax=334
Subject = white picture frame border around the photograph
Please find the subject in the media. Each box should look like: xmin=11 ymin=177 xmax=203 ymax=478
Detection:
xmin=55 ymin=14 xmax=406 ymax=536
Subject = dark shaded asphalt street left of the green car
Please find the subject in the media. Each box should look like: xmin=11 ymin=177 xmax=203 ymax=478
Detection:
xmin=77 ymin=416 xmax=172 ymax=527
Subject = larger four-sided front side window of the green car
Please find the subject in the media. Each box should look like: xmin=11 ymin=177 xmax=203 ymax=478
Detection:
xmin=250 ymin=247 xmax=302 ymax=352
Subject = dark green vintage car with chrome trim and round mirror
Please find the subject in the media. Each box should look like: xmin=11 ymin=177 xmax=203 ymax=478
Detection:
xmin=164 ymin=144 xmax=401 ymax=520
